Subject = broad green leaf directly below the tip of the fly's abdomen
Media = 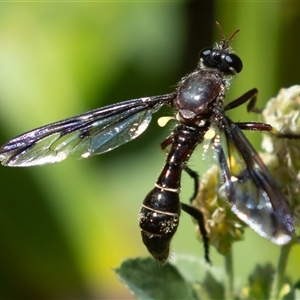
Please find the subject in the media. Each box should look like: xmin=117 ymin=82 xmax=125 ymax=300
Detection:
xmin=115 ymin=255 xmax=224 ymax=299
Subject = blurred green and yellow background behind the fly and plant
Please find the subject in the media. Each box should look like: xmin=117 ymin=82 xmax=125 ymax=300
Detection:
xmin=0 ymin=1 xmax=300 ymax=299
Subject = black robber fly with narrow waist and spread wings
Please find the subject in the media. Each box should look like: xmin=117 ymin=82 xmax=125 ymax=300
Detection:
xmin=0 ymin=23 xmax=299 ymax=263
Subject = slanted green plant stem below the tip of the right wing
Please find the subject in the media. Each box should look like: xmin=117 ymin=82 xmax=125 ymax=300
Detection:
xmin=270 ymin=241 xmax=294 ymax=299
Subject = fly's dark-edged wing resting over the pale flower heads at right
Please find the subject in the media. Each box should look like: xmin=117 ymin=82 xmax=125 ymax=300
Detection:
xmin=214 ymin=116 xmax=294 ymax=245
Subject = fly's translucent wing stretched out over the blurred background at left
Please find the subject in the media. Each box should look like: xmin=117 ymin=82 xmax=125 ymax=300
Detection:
xmin=0 ymin=94 xmax=173 ymax=167
